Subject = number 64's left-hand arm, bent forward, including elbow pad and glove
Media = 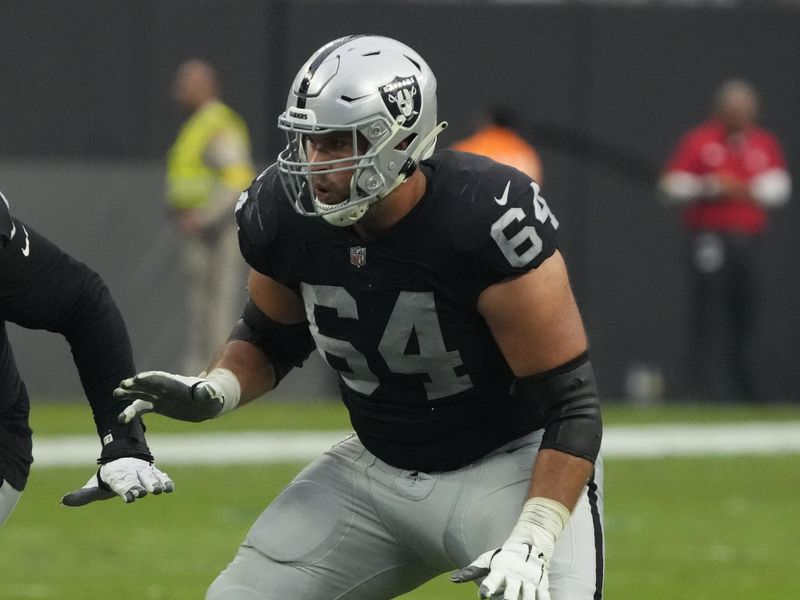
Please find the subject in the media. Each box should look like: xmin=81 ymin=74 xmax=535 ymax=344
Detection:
xmin=115 ymin=271 xmax=314 ymax=422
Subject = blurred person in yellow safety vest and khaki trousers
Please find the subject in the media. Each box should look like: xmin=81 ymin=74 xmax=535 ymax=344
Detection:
xmin=166 ymin=58 xmax=255 ymax=373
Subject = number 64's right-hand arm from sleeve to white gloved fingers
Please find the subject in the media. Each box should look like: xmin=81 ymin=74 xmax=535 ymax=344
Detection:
xmin=452 ymin=252 xmax=602 ymax=598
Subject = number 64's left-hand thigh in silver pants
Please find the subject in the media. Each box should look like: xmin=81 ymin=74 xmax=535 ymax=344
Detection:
xmin=207 ymin=439 xmax=433 ymax=600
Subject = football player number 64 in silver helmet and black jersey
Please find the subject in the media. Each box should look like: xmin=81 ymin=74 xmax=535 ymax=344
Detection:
xmin=115 ymin=36 xmax=603 ymax=600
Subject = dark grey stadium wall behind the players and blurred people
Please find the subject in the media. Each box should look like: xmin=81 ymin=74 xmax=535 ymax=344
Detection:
xmin=0 ymin=0 xmax=800 ymax=400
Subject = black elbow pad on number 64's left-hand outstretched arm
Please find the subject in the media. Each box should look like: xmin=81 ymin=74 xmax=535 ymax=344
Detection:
xmin=228 ymin=300 xmax=315 ymax=386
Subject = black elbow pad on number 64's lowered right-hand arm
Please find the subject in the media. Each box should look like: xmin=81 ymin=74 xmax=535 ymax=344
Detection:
xmin=517 ymin=352 xmax=603 ymax=463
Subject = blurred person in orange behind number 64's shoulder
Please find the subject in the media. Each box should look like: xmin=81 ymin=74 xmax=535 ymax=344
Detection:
xmin=453 ymin=108 xmax=542 ymax=185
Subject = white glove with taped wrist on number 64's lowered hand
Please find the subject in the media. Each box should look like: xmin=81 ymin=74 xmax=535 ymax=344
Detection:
xmin=450 ymin=497 xmax=569 ymax=600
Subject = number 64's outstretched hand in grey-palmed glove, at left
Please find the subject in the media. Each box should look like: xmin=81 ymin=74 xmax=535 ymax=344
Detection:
xmin=114 ymin=371 xmax=225 ymax=423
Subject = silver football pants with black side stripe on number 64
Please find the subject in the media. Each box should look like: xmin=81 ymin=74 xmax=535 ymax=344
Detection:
xmin=206 ymin=431 xmax=603 ymax=600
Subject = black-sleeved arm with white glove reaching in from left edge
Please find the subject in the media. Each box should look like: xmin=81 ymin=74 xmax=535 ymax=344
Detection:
xmin=0 ymin=216 xmax=173 ymax=506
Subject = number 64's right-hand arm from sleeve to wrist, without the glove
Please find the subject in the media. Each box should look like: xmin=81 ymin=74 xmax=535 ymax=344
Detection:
xmin=478 ymin=252 xmax=601 ymax=510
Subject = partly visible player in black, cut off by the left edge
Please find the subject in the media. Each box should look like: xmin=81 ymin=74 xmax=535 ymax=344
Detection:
xmin=0 ymin=193 xmax=174 ymax=524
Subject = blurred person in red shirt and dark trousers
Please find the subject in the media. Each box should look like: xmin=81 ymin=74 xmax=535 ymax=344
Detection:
xmin=659 ymin=79 xmax=791 ymax=401
